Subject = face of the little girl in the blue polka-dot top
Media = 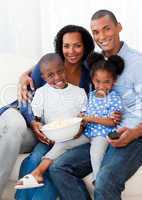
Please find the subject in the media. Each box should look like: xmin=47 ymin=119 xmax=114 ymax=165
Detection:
xmin=92 ymin=69 xmax=115 ymax=96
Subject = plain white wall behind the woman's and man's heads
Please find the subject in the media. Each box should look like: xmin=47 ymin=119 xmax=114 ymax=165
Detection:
xmin=40 ymin=0 xmax=142 ymax=53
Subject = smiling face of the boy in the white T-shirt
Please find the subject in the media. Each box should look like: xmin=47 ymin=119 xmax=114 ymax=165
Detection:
xmin=40 ymin=60 xmax=67 ymax=89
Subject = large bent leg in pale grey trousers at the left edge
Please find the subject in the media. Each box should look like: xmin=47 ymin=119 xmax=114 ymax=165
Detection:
xmin=0 ymin=109 xmax=36 ymax=196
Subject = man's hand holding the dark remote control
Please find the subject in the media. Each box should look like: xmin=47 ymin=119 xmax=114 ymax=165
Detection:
xmin=107 ymin=127 xmax=136 ymax=147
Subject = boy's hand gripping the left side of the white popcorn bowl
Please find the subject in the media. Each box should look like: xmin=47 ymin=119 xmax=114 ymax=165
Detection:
xmin=31 ymin=121 xmax=54 ymax=144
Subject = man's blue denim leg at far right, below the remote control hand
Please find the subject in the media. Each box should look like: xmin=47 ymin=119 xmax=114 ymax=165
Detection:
xmin=94 ymin=138 xmax=142 ymax=200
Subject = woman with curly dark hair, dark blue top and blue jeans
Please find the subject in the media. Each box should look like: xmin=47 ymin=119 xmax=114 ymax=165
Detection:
xmin=16 ymin=25 xmax=94 ymax=200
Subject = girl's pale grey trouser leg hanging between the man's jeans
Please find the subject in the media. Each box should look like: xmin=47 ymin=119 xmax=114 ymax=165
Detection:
xmin=90 ymin=136 xmax=108 ymax=181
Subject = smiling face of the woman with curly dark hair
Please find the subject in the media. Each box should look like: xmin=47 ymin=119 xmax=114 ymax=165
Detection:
xmin=63 ymin=32 xmax=84 ymax=64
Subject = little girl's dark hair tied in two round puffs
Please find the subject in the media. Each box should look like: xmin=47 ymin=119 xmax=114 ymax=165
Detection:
xmin=91 ymin=53 xmax=124 ymax=80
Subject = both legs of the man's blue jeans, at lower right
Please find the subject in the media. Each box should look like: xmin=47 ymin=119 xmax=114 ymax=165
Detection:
xmin=49 ymin=138 xmax=142 ymax=200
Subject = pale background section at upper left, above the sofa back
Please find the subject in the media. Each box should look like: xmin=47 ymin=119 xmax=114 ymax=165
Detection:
xmin=0 ymin=0 xmax=41 ymax=58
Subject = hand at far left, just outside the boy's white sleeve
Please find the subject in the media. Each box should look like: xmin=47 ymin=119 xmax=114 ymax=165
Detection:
xmin=18 ymin=73 xmax=34 ymax=101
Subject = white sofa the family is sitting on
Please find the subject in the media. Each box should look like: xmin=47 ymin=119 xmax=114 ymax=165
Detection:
xmin=0 ymin=55 xmax=142 ymax=200
